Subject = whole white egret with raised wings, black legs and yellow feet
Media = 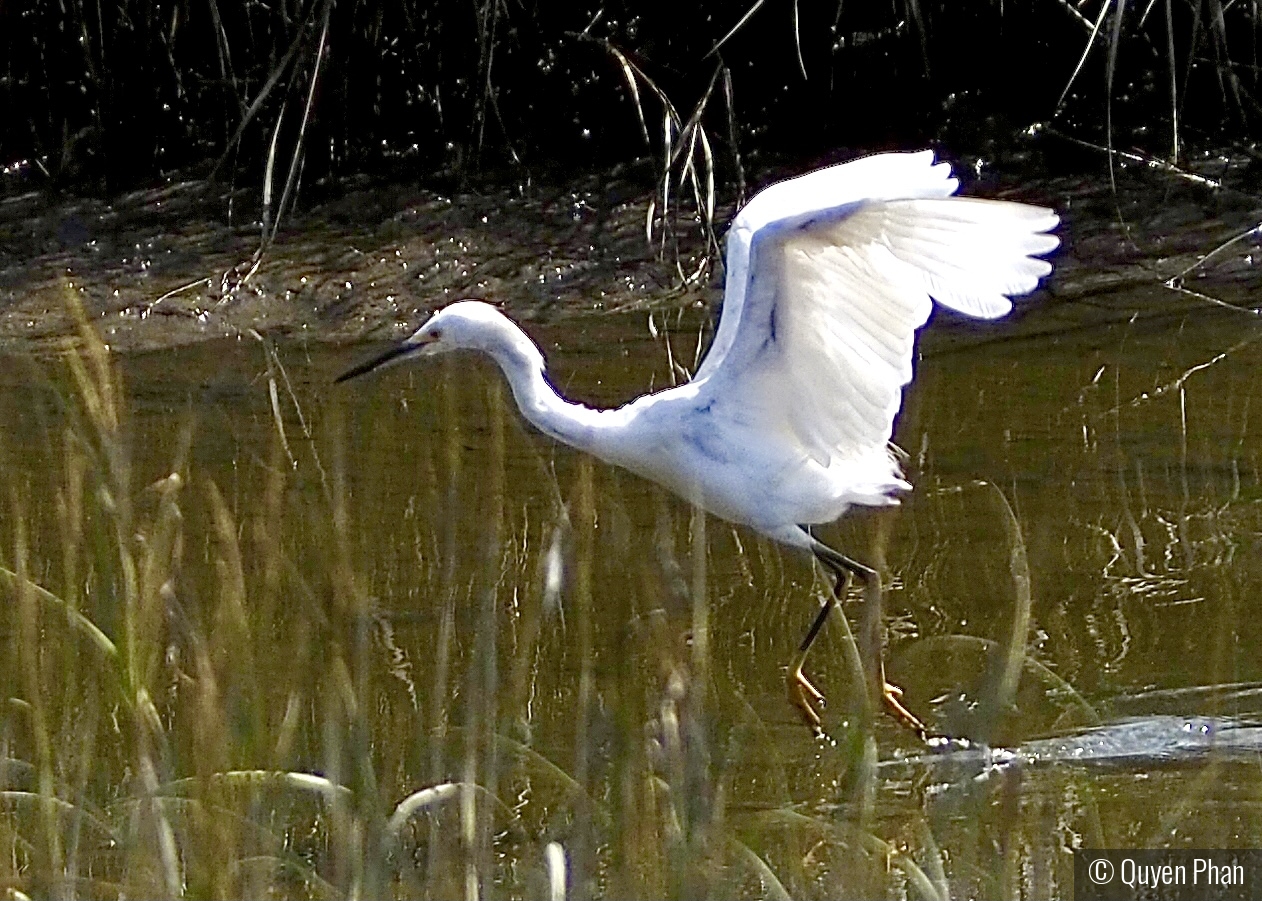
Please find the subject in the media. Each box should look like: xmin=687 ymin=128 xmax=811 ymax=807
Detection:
xmin=338 ymin=150 xmax=1059 ymax=734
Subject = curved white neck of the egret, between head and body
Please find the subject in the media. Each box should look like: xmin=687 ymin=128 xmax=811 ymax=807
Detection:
xmin=490 ymin=334 xmax=612 ymax=454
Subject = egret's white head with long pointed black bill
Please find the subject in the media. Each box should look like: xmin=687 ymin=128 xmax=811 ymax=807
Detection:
xmin=337 ymin=300 xmax=538 ymax=382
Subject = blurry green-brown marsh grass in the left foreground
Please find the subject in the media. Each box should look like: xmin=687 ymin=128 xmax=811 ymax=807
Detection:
xmin=0 ymin=292 xmax=954 ymax=898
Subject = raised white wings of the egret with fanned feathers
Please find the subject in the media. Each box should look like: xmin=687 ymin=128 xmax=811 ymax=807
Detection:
xmin=693 ymin=150 xmax=1059 ymax=467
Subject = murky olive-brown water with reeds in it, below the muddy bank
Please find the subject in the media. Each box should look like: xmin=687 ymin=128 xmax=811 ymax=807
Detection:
xmin=0 ymin=295 xmax=1262 ymax=897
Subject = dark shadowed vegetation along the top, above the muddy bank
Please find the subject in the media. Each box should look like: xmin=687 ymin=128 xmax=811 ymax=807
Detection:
xmin=0 ymin=0 xmax=1258 ymax=192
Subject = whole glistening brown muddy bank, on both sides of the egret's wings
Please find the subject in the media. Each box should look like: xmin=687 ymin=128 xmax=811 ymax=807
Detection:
xmin=0 ymin=157 xmax=1262 ymax=353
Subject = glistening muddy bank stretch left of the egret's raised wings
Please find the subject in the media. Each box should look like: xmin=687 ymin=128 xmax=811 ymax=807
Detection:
xmin=0 ymin=169 xmax=709 ymax=352
